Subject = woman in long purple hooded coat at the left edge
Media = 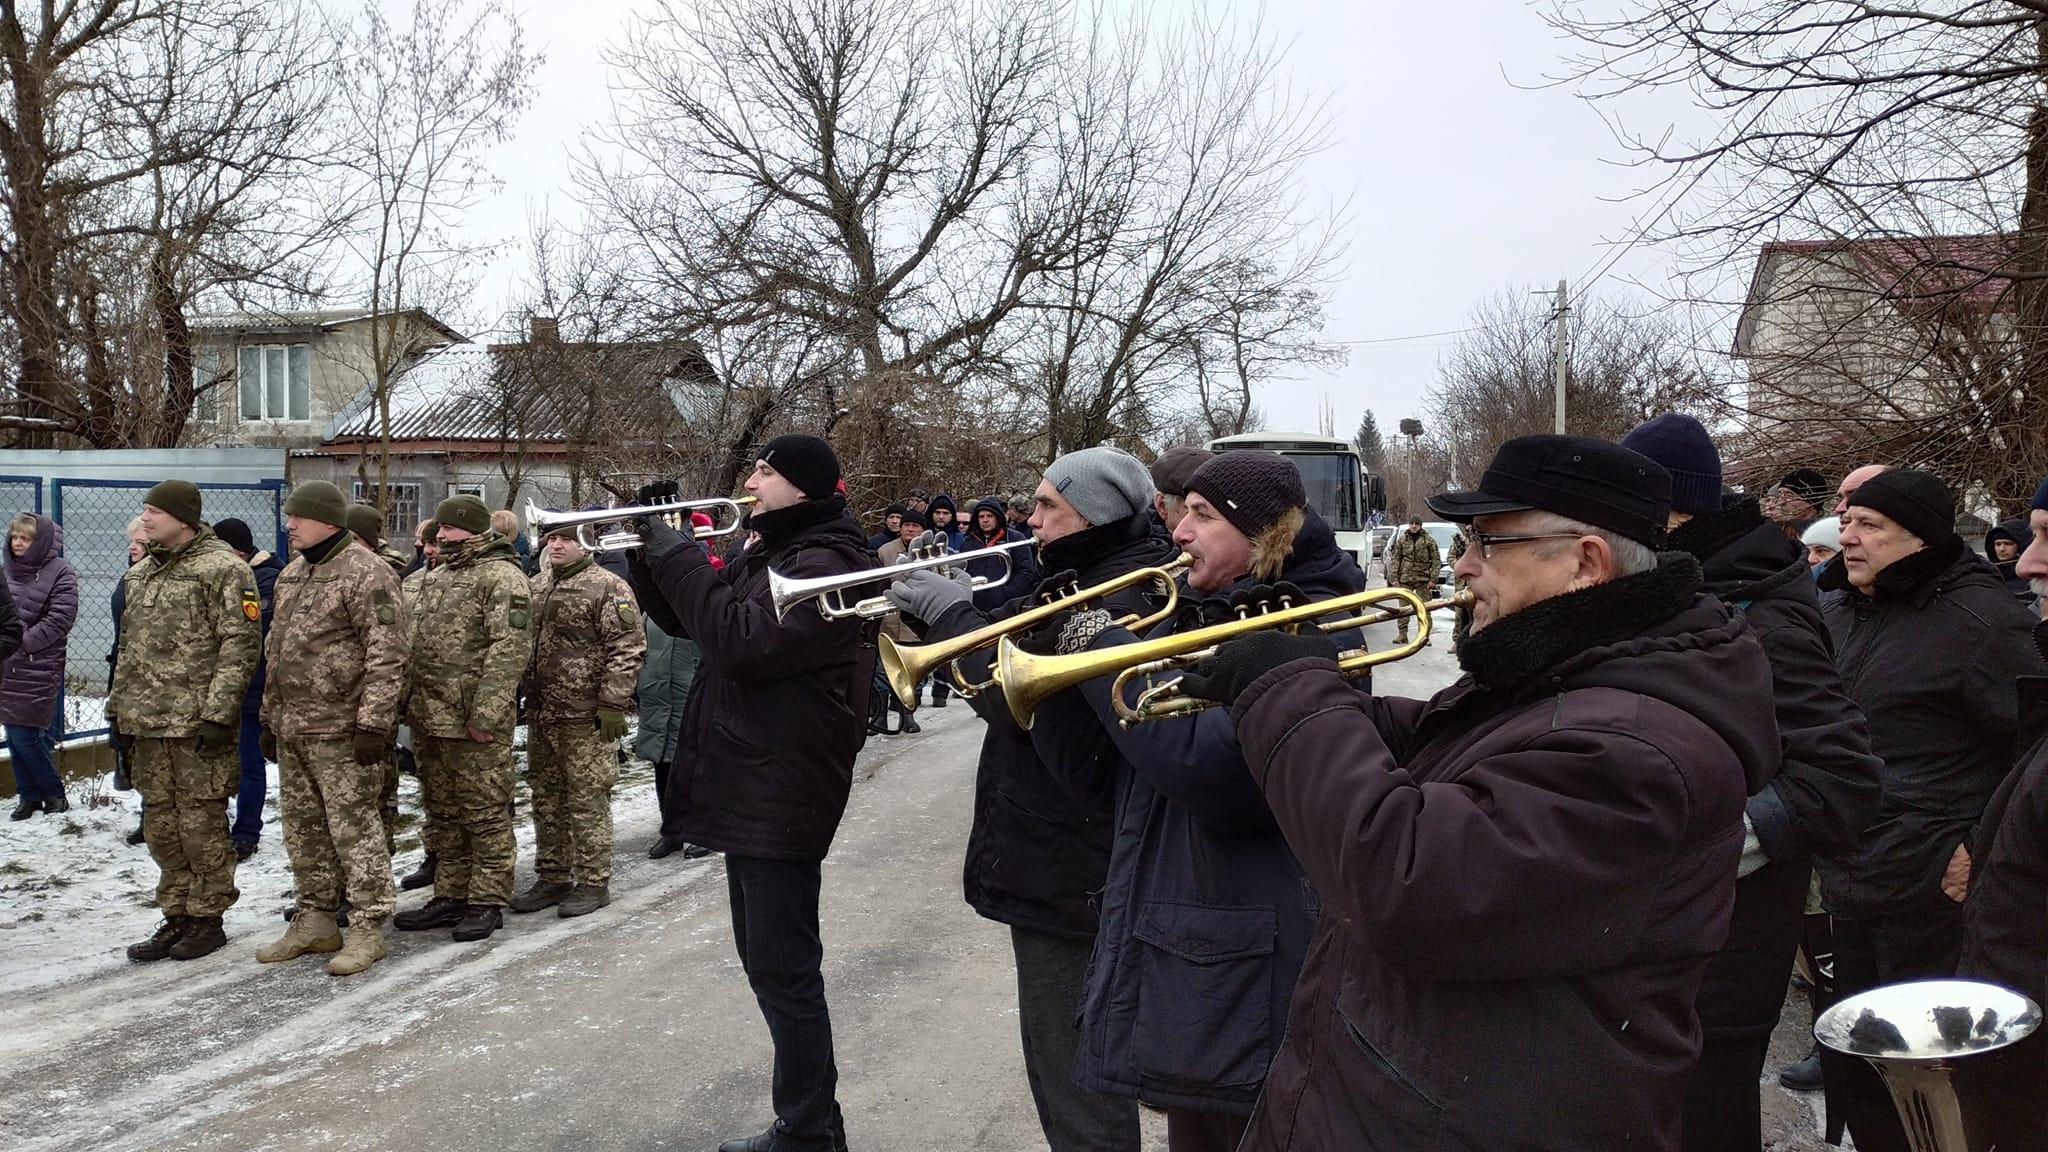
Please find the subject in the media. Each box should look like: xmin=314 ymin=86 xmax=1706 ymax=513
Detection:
xmin=0 ymin=512 xmax=78 ymax=820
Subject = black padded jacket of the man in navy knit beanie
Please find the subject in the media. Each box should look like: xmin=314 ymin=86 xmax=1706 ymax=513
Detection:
xmin=1671 ymin=496 xmax=1880 ymax=1039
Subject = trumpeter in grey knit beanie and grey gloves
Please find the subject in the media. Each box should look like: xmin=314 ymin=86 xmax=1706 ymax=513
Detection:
xmin=889 ymin=447 xmax=1171 ymax=1152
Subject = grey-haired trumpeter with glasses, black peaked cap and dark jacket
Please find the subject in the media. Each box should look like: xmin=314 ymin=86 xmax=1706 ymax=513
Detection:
xmin=1184 ymin=435 xmax=1778 ymax=1152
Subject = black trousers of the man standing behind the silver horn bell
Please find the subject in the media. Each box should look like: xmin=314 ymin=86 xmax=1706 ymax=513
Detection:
xmin=1821 ymin=892 xmax=1962 ymax=1152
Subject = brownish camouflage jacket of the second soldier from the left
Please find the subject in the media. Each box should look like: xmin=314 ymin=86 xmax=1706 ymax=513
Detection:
xmin=262 ymin=543 xmax=408 ymax=740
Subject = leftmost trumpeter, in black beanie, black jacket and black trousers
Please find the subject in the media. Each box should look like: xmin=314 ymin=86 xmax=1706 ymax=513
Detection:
xmin=633 ymin=435 xmax=877 ymax=1152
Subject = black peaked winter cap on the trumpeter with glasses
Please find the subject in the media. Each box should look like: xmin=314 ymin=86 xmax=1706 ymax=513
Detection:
xmin=1427 ymin=433 xmax=1671 ymax=547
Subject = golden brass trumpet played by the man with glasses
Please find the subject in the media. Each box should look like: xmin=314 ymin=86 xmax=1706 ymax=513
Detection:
xmin=995 ymin=588 xmax=1470 ymax=728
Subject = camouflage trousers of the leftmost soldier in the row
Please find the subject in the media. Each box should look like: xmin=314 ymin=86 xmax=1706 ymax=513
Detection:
xmin=129 ymin=736 xmax=242 ymax=916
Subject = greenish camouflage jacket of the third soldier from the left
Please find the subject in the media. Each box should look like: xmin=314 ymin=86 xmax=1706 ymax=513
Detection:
xmin=406 ymin=533 xmax=532 ymax=742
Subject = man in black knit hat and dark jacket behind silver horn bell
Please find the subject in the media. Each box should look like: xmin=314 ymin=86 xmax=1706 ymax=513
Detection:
xmin=1819 ymin=467 xmax=2042 ymax=1152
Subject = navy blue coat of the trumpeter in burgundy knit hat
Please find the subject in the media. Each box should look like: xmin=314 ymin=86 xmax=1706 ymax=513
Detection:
xmin=1032 ymin=504 xmax=1366 ymax=1115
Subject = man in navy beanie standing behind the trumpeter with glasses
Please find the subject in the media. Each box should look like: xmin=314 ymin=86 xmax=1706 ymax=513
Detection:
xmin=1622 ymin=414 xmax=1880 ymax=1152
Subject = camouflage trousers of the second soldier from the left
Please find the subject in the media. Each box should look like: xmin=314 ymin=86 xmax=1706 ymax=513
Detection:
xmin=279 ymin=738 xmax=397 ymax=920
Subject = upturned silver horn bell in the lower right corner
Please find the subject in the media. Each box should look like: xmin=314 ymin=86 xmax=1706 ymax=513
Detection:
xmin=1812 ymin=980 xmax=2042 ymax=1152
